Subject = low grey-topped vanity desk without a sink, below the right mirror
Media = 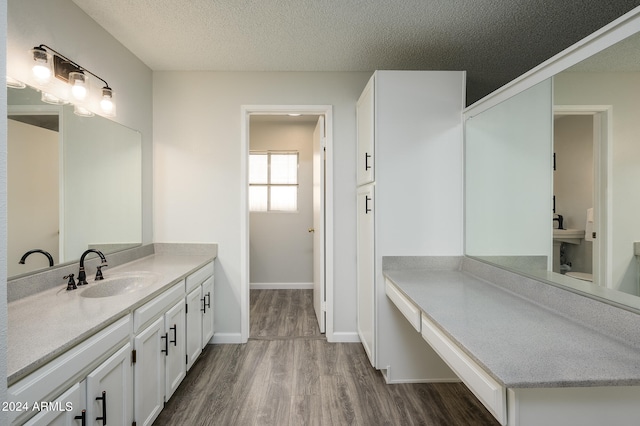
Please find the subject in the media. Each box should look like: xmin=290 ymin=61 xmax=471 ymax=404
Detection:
xmin=384 ymin=257 xmax=640 ymax=426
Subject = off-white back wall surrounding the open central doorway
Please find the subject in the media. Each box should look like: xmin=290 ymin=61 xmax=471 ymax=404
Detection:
xmin=153 ymin=72 xmax=371 ymax=335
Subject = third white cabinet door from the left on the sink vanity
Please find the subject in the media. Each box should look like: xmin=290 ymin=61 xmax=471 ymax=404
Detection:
xmin=134 ymin=317 xmax=162 ymax=425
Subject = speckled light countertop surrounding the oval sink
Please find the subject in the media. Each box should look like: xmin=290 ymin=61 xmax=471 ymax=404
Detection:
xmin=7 ymin=253 xmax=213 ymax=385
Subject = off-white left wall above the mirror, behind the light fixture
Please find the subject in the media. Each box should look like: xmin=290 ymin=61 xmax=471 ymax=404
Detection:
xmin=7 ymin=0 xmax=153 ymax=243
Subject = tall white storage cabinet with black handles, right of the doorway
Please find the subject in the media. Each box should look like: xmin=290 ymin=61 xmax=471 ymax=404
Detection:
xmin=357 ymin=71 xmax=465 ymax=382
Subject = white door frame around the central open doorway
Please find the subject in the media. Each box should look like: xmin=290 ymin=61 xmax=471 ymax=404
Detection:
xmin=239 ymin=105 xmax=333 ymax=342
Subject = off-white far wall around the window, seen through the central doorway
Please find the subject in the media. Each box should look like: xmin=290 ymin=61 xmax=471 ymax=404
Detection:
xmin=249 ymin=118 xmax=316 ymax=288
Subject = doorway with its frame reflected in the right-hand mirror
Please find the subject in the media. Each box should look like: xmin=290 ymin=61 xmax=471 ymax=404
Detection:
xmin=553 ymin=105 xmax=612 ymax=287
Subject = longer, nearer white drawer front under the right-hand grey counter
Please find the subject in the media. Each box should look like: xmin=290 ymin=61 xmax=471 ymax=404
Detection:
xmin=422 ymin=315 xmax=507 ymax=425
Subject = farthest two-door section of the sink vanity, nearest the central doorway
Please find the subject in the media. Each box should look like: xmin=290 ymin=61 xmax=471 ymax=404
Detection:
xmin=185 ymin=262 xmax=214 ymax=370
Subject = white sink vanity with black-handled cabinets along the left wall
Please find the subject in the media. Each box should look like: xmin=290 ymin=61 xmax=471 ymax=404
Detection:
xmin=7 ymin=245 xmax=217 ymax=425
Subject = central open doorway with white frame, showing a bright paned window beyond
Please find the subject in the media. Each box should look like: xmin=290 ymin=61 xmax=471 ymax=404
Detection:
xmin=240 ymin=106 xmax=333 ymax=341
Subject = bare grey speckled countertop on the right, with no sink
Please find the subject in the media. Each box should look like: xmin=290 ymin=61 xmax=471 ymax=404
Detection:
xmin=385 ymin=270 xmax=640 ymax=388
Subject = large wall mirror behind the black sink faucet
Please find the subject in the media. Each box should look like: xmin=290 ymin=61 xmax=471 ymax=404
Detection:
xmin=7 ymin=81 xmax=142 ymax=279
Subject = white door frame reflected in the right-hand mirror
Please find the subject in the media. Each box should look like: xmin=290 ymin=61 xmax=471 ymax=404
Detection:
xmin=553 ymin=105 xmax=613 ymax=288
